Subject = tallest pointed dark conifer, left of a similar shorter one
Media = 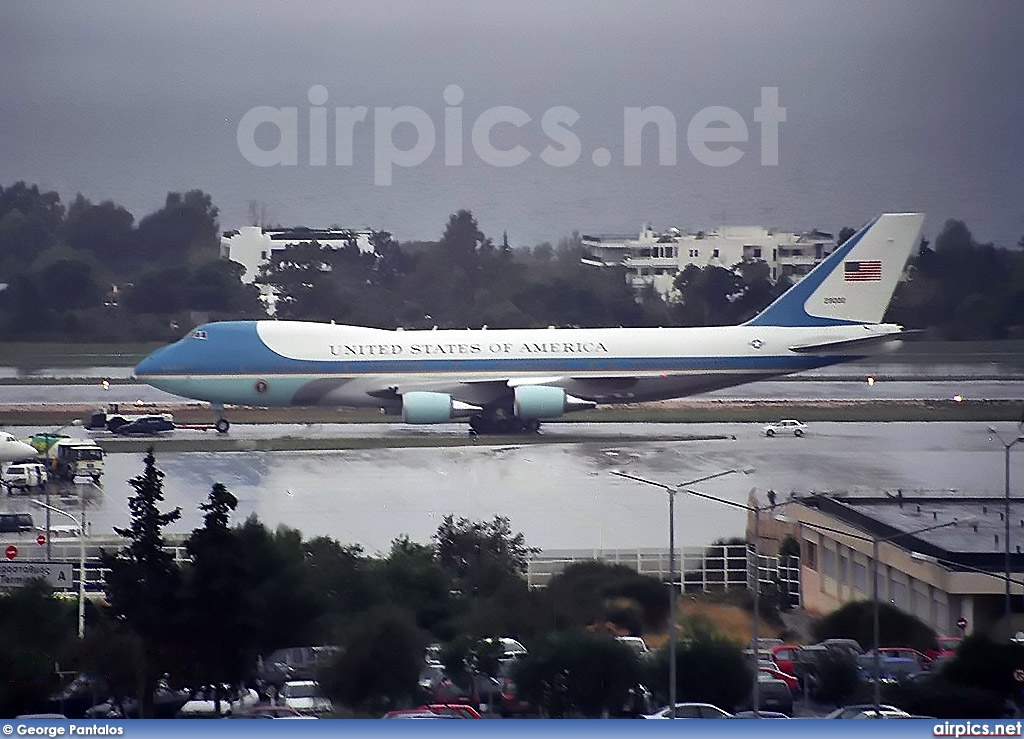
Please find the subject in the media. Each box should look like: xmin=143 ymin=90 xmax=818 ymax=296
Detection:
xmin=100 ymin=447 xmax=181 ymax=719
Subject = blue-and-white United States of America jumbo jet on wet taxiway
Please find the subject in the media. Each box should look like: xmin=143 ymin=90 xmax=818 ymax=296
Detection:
xmin=135 ymin=213 xmax=924 ymax=433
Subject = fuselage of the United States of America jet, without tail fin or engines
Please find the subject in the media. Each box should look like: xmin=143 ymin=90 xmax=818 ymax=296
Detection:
xmin=136 ymin=321 xmax=899 ymax=407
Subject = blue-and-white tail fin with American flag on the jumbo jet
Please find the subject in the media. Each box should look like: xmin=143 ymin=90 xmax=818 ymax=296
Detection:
xmin=744 ymin=213 xmax=925 ymax=327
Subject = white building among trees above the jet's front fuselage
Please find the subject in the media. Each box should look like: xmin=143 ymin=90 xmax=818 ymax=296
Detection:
xmin=220 ymin=226 xmax=374 ymax=315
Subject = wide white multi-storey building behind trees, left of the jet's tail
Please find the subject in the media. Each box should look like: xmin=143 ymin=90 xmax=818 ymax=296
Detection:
xmin=583 ymin=225 xmax=836 ymax=297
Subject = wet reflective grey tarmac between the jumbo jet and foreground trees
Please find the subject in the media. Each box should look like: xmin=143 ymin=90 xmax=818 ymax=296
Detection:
xmin=6 ymin=423 xmax=1024 ymax=553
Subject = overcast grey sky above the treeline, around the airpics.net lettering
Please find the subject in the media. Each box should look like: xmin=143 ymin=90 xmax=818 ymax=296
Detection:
xmin=0 ymin=0 xmax=1024 ymax=246
